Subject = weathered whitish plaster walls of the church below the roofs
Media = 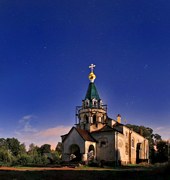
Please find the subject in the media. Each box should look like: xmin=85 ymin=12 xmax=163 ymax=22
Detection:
xmin=63 ymin=126 xmax=149 ymax=164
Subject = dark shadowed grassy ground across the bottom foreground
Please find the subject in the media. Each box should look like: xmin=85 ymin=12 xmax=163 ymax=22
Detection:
xmin=0 ymin=166 xmax=170 ymax=180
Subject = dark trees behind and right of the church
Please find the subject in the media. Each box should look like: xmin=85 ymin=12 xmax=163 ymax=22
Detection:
xmin=126 ymin=124 xmax=170 ymax=164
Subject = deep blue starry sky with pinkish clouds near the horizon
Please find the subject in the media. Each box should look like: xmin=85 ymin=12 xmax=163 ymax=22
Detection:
xmin=0 ymin=0 xmax=170 ymax=146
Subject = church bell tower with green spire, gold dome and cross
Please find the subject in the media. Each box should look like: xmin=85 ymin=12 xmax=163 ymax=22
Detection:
xmin=76 ymin=64 xmax=107 ymax=132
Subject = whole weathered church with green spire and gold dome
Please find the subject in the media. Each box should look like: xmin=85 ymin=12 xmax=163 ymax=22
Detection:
xmin=61 ymin=64 xmax=149 ymax=164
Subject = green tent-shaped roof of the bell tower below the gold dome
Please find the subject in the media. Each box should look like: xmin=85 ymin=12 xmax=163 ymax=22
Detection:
xmin=85 ymin=82 xmax=100 ymax=100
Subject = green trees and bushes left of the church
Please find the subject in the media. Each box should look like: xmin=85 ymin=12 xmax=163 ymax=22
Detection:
xmin=0 ymin=138 xmax=61 ymax=166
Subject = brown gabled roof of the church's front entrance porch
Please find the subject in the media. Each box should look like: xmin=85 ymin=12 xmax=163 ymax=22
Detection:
xmin=61 ymin=127 xmax=96 ymax=142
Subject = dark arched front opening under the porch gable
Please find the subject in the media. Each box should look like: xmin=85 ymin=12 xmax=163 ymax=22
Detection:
xmin=70 ymin=144 xmax=81 ymax=162
